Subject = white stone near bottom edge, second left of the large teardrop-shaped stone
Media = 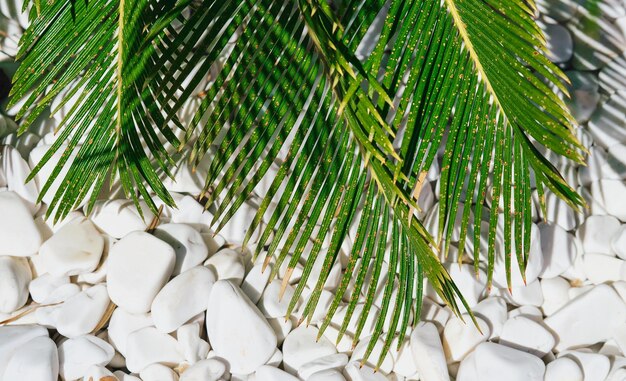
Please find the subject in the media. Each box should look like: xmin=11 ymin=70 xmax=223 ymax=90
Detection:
xmin=126 ymin=327 xmax=185 ymax=373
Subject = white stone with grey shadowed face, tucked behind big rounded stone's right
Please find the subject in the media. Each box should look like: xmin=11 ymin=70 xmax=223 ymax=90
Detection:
xmin=154 ymin=224 xmax=209 ymax=275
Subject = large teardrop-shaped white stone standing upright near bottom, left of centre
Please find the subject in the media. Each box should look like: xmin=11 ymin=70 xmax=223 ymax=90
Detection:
xmin=206 ymin=280 xmax=276 ymax=374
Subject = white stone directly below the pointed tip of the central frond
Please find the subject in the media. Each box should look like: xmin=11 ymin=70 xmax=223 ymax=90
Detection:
xmin=443 ymin=314 xmax=491 ymax=361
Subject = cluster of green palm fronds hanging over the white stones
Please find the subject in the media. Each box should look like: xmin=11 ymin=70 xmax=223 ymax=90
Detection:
xmin=7 ymin=0 xmax=583 ymax=361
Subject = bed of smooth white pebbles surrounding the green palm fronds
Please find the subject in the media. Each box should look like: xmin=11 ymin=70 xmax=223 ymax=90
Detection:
xmin=0 ymin=0 xmax=626 ymax=381
